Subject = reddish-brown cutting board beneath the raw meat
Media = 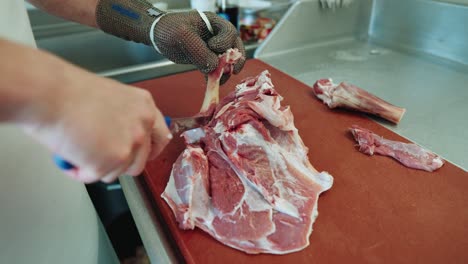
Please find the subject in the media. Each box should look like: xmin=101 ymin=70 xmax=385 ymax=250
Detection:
xmin=136 ymin=60 xmax=468 ymax=264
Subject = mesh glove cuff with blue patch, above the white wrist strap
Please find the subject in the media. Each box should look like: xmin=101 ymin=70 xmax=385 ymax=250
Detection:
xmin=96 ymin=0 xmax=166 ymax=45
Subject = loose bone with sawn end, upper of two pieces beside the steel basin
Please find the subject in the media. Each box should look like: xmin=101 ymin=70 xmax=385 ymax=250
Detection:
xmin=312 ymin=79 xmax=406 ymax=124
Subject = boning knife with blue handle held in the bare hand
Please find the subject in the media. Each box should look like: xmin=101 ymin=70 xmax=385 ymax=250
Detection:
xmin=53 ymin=116 xmax=211 ymax=170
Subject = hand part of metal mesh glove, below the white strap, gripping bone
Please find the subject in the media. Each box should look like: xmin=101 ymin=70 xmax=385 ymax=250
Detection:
xmin=154 ymin=11 xmax=245 ymax=76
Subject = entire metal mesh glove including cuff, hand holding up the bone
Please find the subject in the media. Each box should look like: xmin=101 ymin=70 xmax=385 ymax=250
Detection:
xmin=96 ymin=0 xmax=246 ymax=83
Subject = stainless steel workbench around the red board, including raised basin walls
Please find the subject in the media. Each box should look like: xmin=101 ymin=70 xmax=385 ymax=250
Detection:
xmin=121 ymin=0 xmax=468 ymax=263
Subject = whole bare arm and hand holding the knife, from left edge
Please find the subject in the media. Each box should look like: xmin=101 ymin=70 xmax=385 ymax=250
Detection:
xmin=0 ymin=38 xmax=170 ymax=183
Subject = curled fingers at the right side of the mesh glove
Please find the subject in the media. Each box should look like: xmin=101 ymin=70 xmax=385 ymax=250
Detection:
xmin=207 ymin=13 xmax=238 ymax=54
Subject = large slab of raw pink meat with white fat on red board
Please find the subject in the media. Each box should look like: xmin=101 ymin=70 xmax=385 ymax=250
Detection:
xmin=162 ymin=71 xmax=333 ymax=254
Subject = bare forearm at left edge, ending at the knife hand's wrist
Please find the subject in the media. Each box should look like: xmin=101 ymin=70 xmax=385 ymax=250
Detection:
xmin=0 ymin=38 xmax=79 ymax=124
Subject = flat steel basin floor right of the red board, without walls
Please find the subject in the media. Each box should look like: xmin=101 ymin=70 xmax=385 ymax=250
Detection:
xmin=258 ymin=39 xmax=468 ymax=170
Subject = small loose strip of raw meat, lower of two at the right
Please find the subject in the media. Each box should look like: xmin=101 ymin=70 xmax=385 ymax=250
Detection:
xmin=350 ymin=125 xmax=444 ymax=171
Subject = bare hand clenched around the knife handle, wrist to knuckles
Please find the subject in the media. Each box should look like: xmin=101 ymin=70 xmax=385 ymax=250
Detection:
xmin=25 ymin=73 xmax=171 ymax=183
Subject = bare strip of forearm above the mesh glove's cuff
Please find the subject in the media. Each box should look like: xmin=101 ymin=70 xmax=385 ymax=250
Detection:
xmin=28 ymin=0 xmax=98 ymax=27
